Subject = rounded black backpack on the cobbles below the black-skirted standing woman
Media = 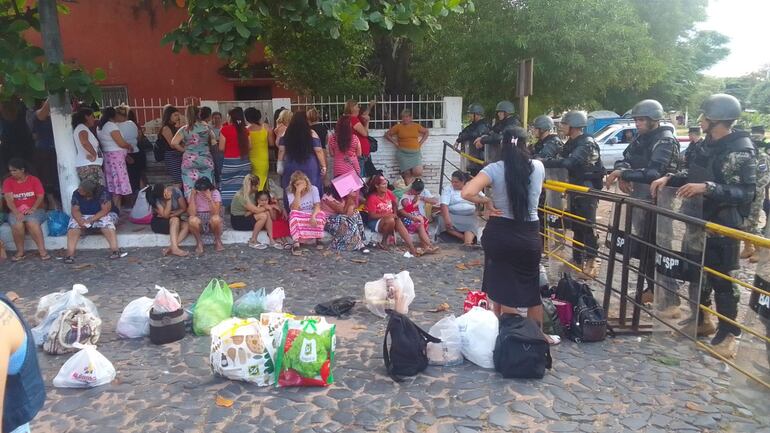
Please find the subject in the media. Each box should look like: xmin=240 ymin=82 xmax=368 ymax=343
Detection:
xmin=493 ymin=314 xmax=553 ymax=379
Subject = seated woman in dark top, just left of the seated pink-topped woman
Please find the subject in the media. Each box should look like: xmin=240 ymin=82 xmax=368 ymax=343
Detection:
xmin=150 ymin=183 xmax=190 ymax=257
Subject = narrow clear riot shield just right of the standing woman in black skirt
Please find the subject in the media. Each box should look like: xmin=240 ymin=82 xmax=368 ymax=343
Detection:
xmin=541 ymin=168 xmax=571 ymax=284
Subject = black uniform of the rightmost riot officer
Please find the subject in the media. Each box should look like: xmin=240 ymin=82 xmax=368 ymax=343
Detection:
xmin=668 ymin=131 xmax=757 ymax=335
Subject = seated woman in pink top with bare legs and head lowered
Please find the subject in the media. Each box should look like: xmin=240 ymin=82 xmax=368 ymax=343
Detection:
xmin=187 ymin=176 xmax=225 ymax=256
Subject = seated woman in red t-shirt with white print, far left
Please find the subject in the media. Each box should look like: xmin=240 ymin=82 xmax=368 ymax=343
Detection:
xmin=3 ymin=158 xmax=51 ymax=262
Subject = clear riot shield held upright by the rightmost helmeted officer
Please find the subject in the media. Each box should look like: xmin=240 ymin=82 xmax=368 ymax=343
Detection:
xmin=653 ymin=187 xmax=706 ymax=338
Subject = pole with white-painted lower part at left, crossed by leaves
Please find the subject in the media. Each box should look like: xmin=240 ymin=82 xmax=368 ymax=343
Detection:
xmin=37 ymin=0 xmax=80 ymax=215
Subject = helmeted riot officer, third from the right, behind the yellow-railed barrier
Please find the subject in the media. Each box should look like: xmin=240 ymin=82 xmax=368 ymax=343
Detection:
xmin=543 ymin=111 xmax=604 ymax=278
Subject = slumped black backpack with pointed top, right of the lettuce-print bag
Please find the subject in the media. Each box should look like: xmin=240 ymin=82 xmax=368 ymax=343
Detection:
xmin=382 ymin=310 xmax=441 ymax=382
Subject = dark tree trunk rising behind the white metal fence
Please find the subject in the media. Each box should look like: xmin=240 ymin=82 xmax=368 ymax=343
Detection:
xmin=373 ymin=32 xmax=414 ymax=95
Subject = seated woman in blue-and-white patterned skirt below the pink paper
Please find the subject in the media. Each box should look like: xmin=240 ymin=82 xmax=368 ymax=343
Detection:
xmin=321 ymin=185 xmax=369 ymax=253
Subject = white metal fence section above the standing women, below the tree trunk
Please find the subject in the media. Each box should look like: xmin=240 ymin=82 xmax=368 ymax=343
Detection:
xmin=291 ymin=95 xmax=445 ymax=129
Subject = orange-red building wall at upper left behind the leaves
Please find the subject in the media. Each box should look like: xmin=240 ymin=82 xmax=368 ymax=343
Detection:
xmin=25 ymin=0 xmax=293 ymax=100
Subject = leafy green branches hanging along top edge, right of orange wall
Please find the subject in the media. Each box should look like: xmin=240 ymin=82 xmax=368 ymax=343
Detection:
xmin=162 ymin=0 xmax=473 ymax=65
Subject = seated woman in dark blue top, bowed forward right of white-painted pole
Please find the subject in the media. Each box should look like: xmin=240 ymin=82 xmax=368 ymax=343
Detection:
xmin=64 ymin=180 xmax=127 ymax=264
